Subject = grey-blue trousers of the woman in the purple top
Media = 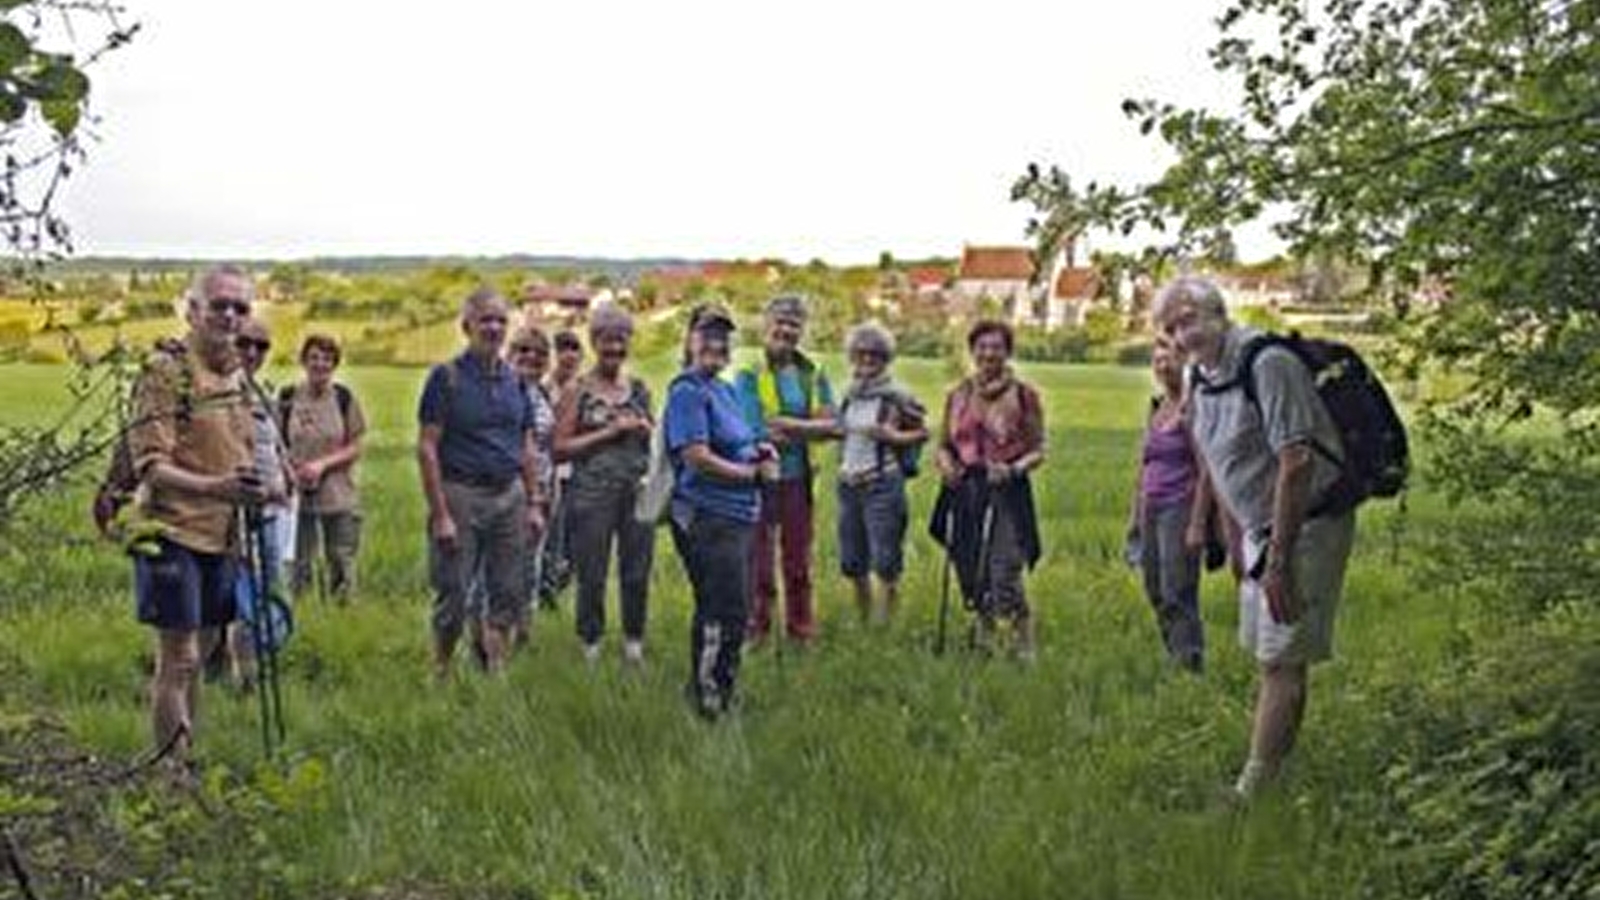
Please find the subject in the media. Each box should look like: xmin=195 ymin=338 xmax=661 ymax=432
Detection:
xmin=1139 ymin=503 xmax=1205 ymax=669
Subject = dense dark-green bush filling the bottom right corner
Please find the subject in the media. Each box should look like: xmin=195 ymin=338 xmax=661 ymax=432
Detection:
xmin=1386 ymin=604 xmax=1600 ymax=900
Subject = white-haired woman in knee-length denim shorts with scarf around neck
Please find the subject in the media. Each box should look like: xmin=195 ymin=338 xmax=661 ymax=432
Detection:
xmin=838 ymin=322 xmax=928 ymax=623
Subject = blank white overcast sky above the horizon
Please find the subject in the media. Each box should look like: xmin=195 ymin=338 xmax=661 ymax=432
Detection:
xmin=53 ymin=0 xmax=1261 ymax=263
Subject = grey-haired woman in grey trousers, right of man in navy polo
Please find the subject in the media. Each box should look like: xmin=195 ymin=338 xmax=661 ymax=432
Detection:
xmin=555 ymin=304 xmax=654 ymax=665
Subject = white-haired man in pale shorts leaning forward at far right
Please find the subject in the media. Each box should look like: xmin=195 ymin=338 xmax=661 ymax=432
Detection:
xmin=1152 ymin=277 xmax=1355 ymax=799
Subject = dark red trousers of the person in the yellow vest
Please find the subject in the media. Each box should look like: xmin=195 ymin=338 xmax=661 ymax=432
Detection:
xmin=750 ymin=479 xmax=816 ymax=641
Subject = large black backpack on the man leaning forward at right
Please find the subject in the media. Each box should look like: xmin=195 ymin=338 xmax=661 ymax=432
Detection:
xmin=1202 ymin=331 xmax=1411 ymax=516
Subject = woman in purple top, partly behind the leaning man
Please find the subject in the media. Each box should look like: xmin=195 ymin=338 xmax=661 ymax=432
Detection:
xmin=1128 ymin=334 xmax=1210 ymax=671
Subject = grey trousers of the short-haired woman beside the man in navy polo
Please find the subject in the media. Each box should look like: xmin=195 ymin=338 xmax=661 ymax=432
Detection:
xmin=568 ymin=480 xmax=656 ymax=644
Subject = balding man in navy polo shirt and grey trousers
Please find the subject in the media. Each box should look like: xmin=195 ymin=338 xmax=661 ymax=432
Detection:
xmin=416 ymin=287 xmax=544 ymax=679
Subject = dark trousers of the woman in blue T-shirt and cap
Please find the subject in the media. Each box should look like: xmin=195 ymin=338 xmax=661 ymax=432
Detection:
xmin=672 ymin=512 xmax=755 ymax=716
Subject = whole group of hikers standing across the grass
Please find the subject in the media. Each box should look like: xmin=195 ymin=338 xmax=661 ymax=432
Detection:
xmin=128 ymin=266 xmax=1376 ymax=798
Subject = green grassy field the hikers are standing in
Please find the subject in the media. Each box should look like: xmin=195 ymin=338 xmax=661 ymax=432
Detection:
xmin=0 ymin=353 xmax=1458 ymax=900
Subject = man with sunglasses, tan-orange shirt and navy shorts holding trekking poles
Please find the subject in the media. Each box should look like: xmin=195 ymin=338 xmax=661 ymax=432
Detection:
xmin=128 ymin=266 xmax=267 ymax=761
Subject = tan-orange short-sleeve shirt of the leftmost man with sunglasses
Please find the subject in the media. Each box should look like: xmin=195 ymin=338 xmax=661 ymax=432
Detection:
xmin=128 ymin=333 xmax=256 ymax=554
